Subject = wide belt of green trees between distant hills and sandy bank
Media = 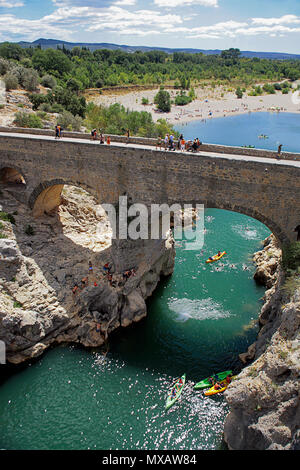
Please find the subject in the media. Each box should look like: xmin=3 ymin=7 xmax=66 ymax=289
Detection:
xmin=0 ymin=43 xmax=300 ymax=89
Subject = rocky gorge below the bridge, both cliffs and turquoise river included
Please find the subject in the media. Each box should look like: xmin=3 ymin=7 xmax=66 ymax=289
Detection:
xmin=0 ymin=178 xmax=299 ymax=449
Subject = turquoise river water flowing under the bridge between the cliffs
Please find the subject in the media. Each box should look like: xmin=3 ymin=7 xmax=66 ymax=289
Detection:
xmin=0 ymin=209 xmax=270 ymax=450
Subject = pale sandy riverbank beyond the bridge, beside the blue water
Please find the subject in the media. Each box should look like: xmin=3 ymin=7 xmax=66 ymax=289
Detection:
xmin=86 ymin=87 xmax=300 ymax=125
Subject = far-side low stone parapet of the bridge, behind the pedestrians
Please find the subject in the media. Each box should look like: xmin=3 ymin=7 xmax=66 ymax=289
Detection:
xmin=0 ymin=126 xmax=300 ymax=161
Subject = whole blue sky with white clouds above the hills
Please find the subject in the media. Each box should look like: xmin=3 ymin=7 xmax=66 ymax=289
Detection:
xmin=0 ymin=0 xmax=300 ymax=54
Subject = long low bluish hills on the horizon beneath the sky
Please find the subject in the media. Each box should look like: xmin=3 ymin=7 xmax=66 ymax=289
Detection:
xmin=18 ymin=38 xmax=300 ymax=60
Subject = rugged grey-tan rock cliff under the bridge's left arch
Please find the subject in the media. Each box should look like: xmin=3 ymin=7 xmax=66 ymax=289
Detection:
xmin=0 ymin=186 xmax=175 ymax=363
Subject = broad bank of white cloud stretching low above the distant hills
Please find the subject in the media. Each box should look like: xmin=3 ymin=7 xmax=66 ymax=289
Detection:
xmin=0 ymin=0 xmax=300 ymax=47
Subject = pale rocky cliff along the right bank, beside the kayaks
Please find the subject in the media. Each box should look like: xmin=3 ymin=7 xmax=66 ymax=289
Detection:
xmin=224 ymin=236 xmax=300 ymax=450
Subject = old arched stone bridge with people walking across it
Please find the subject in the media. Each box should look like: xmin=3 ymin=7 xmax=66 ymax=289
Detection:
xmin=0 ymin=128 xmax=300 ymax=248
